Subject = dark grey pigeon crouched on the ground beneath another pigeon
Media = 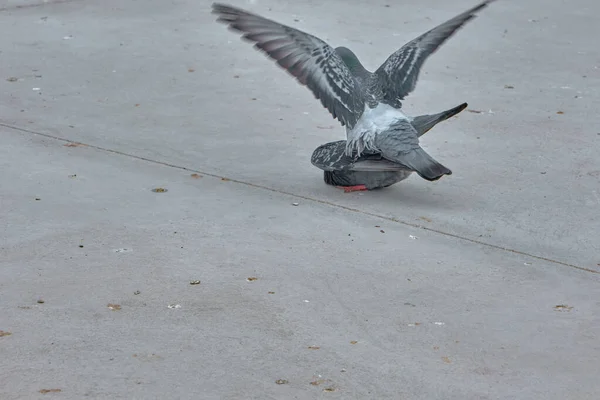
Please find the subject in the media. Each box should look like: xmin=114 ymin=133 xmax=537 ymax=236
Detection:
xmin=311 ymin=103 xmax=467 ymax=193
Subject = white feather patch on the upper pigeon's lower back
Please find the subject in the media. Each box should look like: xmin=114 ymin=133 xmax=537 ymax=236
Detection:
xmin=346 ymin=103 xmax=409 ymax=156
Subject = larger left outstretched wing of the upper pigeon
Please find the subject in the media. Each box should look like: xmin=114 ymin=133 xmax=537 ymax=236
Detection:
xmin=212 ymin=3 xmax=364 ymax=128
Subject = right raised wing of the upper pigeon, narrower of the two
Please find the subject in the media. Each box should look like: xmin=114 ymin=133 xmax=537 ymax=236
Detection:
xmin=375 ymin=0 xmax=494 ymax=101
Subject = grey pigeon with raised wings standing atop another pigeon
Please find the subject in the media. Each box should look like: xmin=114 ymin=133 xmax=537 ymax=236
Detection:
xmin=212 ymin=0 xmax=494 ymax=181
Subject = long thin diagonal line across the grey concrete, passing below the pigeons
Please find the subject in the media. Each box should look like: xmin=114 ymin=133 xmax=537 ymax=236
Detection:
xmin=0 ymin=122 xmax=600 ymax=274
